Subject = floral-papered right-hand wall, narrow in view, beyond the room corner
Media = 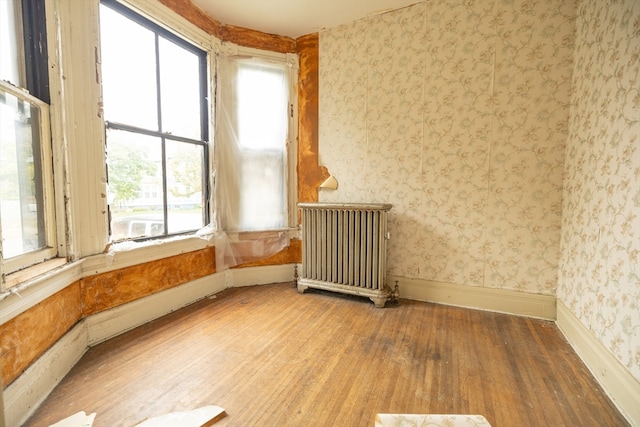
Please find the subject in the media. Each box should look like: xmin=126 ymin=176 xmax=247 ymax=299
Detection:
xmin=557 ymin=0 xmax=640 ymax=380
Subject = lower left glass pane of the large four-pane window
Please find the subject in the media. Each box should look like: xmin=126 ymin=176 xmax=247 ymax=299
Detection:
xmin=107 ymin=130 xmax=165 ymax=240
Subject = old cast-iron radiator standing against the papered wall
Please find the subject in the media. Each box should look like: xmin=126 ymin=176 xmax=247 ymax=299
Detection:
xmin=297 ymin=203 xmax=397 ymax=307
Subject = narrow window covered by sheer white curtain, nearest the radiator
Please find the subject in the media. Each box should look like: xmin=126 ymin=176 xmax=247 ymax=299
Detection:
xmin=216 ymin=56 xmax=293 ymax=231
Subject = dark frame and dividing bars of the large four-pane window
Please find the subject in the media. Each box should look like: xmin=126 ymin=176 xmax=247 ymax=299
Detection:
xmin=99 ymin=0 xmax=212 ymax=244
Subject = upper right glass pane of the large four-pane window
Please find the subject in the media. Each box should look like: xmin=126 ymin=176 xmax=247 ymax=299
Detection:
xmin=159 ymin=37 xmax=202 ymax=139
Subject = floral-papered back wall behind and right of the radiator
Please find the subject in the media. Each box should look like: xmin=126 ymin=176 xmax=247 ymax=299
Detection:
xmin=319 ymin=0 xmax=577 ymax=295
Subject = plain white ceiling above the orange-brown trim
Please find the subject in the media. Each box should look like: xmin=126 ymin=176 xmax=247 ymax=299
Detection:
xmin=192 ymin=0 xmax=423 ymax=38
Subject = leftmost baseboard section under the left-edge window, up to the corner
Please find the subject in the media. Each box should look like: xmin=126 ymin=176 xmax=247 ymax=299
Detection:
xmin=4 ymin=322 xmax=87 ymax=426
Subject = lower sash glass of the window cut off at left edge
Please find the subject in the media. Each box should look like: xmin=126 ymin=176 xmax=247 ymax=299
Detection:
xmin=0 ymin=91 xmax=46 ymax=258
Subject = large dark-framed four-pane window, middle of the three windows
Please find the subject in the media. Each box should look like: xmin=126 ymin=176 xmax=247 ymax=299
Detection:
xmin=100 ymin=1 xmax=209 ymax=241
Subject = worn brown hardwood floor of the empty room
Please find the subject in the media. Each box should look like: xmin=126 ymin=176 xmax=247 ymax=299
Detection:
xmin=26 ymin=283 xmax=628 ymax=427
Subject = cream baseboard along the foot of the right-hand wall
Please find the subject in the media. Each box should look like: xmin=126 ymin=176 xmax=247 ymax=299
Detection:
xmin=556 ymin=301 xmax=640 ymax=426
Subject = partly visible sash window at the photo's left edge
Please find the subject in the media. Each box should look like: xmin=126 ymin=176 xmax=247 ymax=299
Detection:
xmin=0 ymin=0 xmax=57 ymax=290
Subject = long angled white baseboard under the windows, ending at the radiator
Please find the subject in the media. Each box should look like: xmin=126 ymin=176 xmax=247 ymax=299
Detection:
xmin=5 ymin=264 xmax=294 ymax=427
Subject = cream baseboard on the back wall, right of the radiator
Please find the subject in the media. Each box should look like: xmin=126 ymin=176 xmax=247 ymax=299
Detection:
xmin=387 ymin=275 xmax=556 ymax=320
